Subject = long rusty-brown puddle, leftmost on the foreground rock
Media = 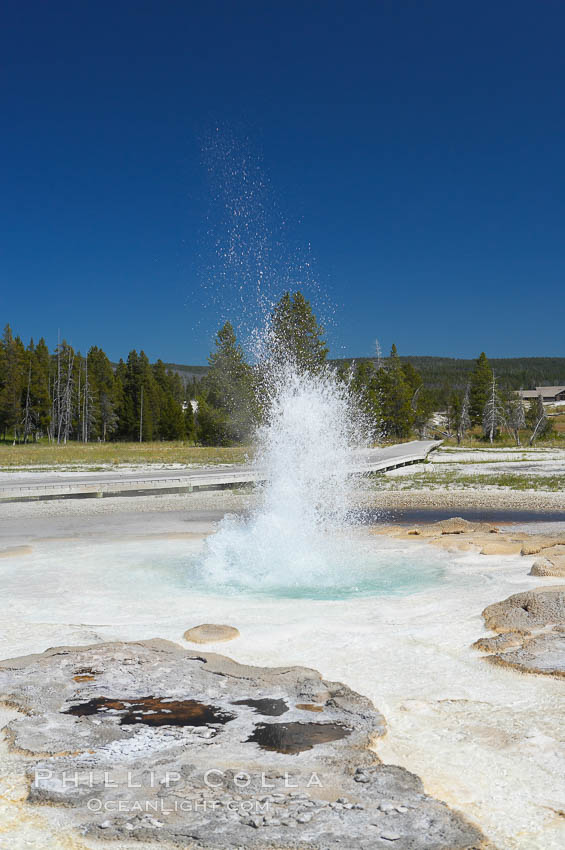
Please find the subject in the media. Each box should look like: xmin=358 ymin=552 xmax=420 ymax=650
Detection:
xmin=62 ymin=697 xmax=235 ymax=726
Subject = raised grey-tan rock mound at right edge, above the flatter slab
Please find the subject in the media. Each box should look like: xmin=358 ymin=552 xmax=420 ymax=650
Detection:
xmin=483 ymin=585 xmax=565 ymax=632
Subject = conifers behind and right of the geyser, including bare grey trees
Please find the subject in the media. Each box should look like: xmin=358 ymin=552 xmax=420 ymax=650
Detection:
xmin=198 ymin=292 xmax=552 ymax=445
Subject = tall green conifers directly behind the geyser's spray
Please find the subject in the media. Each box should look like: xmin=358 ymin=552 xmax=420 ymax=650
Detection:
xmin=192 ymin=292 xmax=433 ymax=445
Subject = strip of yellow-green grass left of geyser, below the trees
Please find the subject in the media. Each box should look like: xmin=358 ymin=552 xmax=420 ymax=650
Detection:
xmin=0 ymin=442 xmax=250 ymax=469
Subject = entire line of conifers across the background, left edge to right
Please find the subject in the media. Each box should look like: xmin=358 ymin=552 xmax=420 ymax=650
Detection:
xmin=0 ymin=292 xmax=552 ymax=446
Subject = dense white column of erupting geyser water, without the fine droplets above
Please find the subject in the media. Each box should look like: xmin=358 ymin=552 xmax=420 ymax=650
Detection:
xmin=205 ymin=353 xmax=370 ymax=591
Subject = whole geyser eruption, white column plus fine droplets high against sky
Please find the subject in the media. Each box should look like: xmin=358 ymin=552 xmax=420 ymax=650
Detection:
xmin=197 ymin=130 xmax=374 ymax=588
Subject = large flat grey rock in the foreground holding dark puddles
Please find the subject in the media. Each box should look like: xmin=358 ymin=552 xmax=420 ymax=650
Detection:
xmin=0 ymin=639 xmax=485 ymax=850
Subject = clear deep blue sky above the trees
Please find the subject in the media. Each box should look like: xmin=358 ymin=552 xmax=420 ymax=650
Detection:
xmin=0 ymin=0 xmax=565 ymax=363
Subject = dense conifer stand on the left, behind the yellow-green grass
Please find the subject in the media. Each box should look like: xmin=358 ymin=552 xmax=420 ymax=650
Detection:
xmin=0 ymin=325 xmax=196 ymax=443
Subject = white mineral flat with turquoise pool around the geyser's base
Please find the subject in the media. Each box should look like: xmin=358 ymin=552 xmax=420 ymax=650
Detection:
xmin=0 ymin=524 xmax=565 ymax=850
